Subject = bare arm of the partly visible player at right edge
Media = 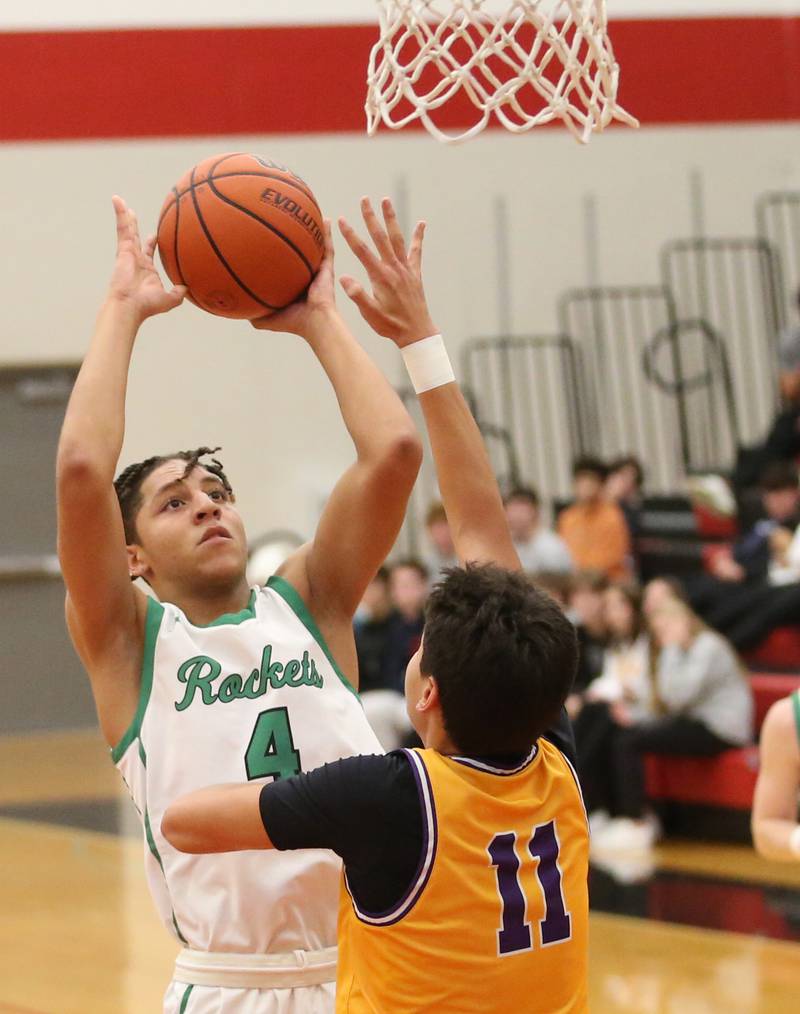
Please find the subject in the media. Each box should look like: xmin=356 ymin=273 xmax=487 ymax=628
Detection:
xmin=752 ymin=691 xmax=800 ymax=863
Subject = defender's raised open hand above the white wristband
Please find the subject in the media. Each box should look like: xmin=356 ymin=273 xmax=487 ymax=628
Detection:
xmin=339 ymin=198 xmax=438 ymax=348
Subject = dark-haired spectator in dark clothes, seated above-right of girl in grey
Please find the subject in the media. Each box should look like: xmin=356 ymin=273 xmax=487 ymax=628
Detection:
xmin=685 ymin=462 xmax=800 ymax=650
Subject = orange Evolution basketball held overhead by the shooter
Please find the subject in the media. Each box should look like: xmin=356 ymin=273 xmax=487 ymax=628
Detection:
xmin=158 ymin=152 xmax=324 ymax=319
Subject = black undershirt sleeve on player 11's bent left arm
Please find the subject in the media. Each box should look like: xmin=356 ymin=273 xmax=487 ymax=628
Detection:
xmin=260 ymin=750 xmax=423 ymax=915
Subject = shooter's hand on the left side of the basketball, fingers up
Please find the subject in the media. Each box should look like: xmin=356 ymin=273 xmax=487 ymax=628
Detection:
xmin=110 ymin=196 xmax=187 ymax=322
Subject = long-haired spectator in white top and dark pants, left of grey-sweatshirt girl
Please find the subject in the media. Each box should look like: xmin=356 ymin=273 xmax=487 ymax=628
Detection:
xmin=574 ymin=581 xmax=656 ymax=831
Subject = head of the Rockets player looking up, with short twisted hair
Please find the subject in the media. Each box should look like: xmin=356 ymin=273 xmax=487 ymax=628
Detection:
xmin=114 ymin=447 xmax=247 ymax=597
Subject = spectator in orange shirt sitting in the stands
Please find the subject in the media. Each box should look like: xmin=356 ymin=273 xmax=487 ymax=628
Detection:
xmin=559 ymin=457 xmax=631 ymax=580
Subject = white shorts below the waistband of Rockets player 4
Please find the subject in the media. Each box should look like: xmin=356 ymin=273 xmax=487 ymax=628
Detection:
xmin=164 ymin=982 xmax=336 ymax=1014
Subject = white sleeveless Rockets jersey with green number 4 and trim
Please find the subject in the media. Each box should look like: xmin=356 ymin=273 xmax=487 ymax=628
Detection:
xmin=112 ymin=577 xmax=382 ymax=957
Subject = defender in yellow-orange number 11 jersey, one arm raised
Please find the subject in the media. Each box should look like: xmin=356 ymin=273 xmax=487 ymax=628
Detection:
xmin=161 ymin=201 xmax=588 ymax=1014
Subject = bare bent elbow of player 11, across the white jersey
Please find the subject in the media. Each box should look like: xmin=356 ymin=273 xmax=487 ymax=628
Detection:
xmin=161 ymin=783 xmax=274 ymax=855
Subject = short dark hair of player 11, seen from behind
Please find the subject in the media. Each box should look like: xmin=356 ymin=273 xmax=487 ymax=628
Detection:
xmin=420 ymin=564 xmax=578 ymax=756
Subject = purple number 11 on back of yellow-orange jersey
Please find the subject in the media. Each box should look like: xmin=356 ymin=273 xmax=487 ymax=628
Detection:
xmin=488 ymin=820 xmax=572 ymax=954
